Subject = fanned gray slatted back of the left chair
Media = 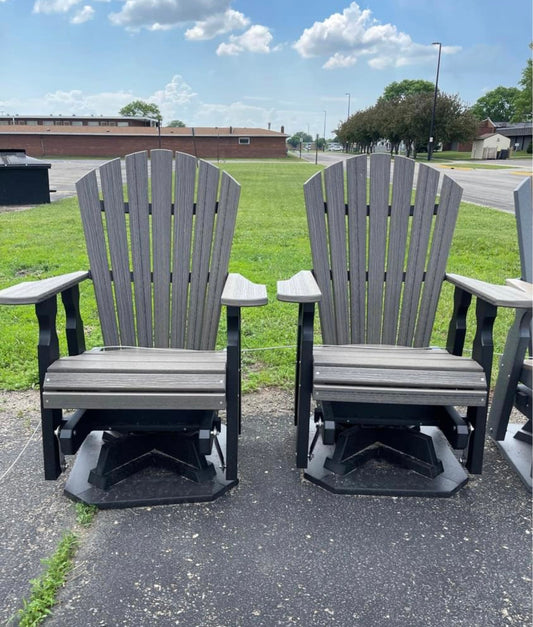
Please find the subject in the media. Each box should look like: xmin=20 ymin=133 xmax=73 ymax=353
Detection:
xmin=76 ymin=150 xmax=240 ymax=349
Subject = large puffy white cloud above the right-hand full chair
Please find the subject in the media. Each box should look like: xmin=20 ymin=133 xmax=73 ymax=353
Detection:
xmin=293 ymin=2 xmax=460 ymax=70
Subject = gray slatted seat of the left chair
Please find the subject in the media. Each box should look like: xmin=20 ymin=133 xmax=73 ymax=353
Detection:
xmin=43 ymin=348 xmax=226 ymax=410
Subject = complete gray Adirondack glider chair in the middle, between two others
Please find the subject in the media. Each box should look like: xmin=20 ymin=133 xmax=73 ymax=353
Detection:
xmin=278 ymin=154 xmax=525 ymax=496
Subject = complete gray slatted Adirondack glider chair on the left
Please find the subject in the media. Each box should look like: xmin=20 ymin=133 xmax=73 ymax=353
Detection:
xmin=0 ymin=150 xmax=267 ymax=507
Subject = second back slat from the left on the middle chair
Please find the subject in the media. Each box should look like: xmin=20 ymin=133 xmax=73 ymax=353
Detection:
xmin=324 ymin=162 xmax=349 ymax=344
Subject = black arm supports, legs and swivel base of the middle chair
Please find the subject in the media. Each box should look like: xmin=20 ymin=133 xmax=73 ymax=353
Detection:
xmin=295 ymin=287 xmax=497 ymax=496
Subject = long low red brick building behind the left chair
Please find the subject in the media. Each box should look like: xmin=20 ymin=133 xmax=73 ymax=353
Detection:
xmin=0 ymin=124 xmax=287 ymax=159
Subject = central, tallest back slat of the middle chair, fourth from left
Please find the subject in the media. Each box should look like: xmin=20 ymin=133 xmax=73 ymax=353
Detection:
xmin=366 ymin=154 xmax=390 ymax=344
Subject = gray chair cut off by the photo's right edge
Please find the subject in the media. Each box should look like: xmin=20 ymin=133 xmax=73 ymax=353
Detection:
xmin=489 ymin=178 xmax=533 ymax=490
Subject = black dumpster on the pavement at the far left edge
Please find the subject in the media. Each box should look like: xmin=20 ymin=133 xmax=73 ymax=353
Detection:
xmin=0 ymin=149 xmax=51 ymax=205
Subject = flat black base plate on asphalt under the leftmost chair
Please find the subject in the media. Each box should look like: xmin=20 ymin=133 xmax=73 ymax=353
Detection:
xmin=65 ymin=425 xmax=238 ymax=509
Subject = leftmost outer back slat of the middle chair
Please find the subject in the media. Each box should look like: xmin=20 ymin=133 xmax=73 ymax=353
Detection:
xmin=304 ymin=172 xmax=337 ymax=344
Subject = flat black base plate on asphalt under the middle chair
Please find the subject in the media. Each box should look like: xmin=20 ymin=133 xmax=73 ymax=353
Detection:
xmin=304 ymin=419 xmax=468 ymax=497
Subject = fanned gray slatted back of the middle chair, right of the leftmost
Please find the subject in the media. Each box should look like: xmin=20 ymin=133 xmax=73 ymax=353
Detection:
xmin=304 ymin=154 xmax=462 ymax=347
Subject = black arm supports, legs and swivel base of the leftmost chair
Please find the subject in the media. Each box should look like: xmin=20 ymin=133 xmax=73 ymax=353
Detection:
xmin=35 ymin=285 xmax=245 ymax=507
